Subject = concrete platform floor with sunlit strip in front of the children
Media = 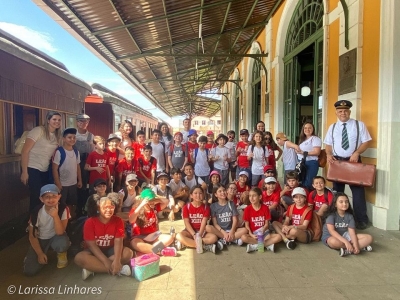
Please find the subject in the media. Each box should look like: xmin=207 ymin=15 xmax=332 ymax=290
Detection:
xmin=0 ymin=220 xmax=400 ymax=300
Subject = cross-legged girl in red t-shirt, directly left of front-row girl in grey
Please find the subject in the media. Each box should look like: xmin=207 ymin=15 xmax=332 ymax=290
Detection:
xmin=176 ymin=185 xmax=218 ymax=254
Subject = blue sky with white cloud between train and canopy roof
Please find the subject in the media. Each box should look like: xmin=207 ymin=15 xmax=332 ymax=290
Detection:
xmin=0 ymin=0 xmax=183 ymax=126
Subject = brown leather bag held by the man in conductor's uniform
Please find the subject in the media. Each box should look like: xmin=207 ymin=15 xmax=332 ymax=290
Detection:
xmin=326 ymin=160 xmax=376 ymax=187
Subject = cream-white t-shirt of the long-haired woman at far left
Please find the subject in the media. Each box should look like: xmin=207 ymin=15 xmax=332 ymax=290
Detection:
xmin=26 ymin=126 xmax=58 ymax=172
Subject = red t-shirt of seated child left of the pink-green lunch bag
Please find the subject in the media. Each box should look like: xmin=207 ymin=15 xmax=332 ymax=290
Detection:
xmin=83 ymin=216 xmax=125 ymax=250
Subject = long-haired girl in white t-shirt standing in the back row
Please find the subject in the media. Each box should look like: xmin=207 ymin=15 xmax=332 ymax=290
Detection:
xmin=247 ymin=130 xmax=269 ymax=187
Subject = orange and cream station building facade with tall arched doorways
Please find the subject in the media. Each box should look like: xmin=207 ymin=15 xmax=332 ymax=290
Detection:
xmin=221 ymin=0 xmax=400 ymax=230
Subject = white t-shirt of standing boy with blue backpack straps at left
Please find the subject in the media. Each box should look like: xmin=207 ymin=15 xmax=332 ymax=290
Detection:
xmin=53 ymin=149 xmax=81 ymax=186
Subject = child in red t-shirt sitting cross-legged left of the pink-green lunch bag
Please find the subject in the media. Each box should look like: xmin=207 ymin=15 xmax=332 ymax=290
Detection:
xmin=75 ymin=196 xmax=133 ymax=280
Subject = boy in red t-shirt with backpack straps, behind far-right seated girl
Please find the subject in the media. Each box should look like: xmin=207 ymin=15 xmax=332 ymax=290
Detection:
xmin=307 ymin=176 xmax=333 ymax=217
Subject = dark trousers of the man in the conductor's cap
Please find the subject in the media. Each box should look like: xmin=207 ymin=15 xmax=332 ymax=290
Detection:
xmin=333 ymin=156 xmax=368 ymax=223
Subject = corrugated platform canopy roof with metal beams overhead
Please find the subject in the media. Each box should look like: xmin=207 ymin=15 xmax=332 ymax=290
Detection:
xmin=33 ymin=0 xmax=282 ymax=117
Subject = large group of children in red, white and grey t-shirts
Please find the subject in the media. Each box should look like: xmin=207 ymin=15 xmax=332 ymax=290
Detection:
xmin=24 ymin=125 xmax=372 ymax=280
